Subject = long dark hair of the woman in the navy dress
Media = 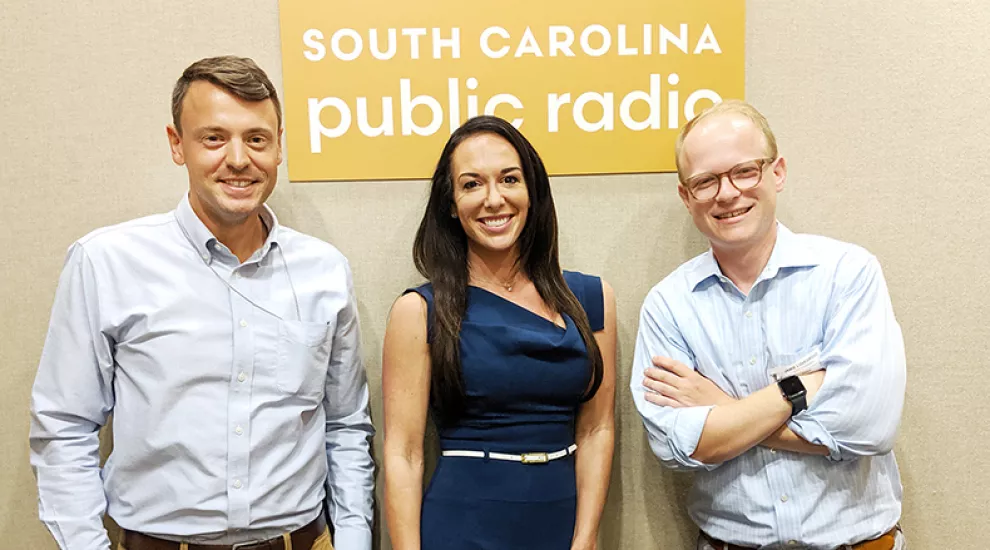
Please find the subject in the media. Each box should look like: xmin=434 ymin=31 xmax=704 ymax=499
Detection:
xmin=413 ymin=116 xmax=603 ymax=424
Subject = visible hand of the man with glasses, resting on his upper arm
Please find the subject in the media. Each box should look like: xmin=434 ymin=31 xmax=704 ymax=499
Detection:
xmin=643 ymin=357 xmax=736 ymax=407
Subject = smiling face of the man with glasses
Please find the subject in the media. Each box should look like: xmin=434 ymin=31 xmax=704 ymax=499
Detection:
xmin=678 ymin=113 xmax=787 ymax=254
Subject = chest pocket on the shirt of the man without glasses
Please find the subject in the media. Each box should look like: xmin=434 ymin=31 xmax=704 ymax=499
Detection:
xmin=275 ymin=321 xmax=333 ymax=401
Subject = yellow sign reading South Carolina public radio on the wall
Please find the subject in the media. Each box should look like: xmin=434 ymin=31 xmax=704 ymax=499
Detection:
xmin=279 ymin=0 xmax=745 ymax=181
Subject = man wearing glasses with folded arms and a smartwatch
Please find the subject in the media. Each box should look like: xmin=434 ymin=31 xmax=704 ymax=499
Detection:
xmin=630 ymin=101 xmax=905 ymax=550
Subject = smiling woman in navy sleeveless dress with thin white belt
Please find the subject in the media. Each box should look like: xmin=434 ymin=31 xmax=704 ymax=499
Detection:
xmin=382 ymin=117 xmax=615 ymax=550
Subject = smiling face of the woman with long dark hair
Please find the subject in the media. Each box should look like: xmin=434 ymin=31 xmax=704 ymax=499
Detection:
xmin=450 ymin=133 xmax=529 ymax=264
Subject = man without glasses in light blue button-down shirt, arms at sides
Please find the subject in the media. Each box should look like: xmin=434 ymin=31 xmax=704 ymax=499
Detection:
xmin=30 ymin=57 xmax=374 ymax=550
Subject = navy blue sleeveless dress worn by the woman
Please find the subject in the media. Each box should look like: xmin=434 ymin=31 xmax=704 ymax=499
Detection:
xmin=407 ymin=271 xmax=605 ymax=550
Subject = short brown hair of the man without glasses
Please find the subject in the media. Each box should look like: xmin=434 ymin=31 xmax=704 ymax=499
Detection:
xmin=172 ymin=55 xmax=282 ymax=134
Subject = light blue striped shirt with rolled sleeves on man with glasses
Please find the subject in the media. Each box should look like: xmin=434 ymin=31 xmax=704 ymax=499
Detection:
xmin=630 ymin=223 xmax=905 ymax=549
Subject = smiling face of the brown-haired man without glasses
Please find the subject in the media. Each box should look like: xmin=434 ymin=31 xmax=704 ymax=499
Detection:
xmin=168 ymin=80 xmax=282 ymax=234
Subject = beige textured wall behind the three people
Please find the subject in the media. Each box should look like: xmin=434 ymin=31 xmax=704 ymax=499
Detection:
xmin=0 ymin=0 xmax=990 ymax=550
